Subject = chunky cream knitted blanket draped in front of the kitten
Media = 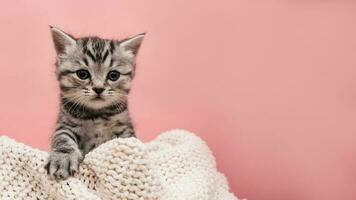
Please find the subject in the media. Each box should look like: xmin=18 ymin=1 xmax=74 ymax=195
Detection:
xmin=0 ymin=130 xmax=237 ymax=200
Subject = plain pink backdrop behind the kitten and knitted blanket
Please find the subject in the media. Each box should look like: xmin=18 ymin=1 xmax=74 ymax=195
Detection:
xmin=0 ymin=0 xmax=356 ymax=200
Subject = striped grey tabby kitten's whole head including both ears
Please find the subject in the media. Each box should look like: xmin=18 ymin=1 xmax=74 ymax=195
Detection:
xmin=51 ymin=28 xmax=144 ymax=109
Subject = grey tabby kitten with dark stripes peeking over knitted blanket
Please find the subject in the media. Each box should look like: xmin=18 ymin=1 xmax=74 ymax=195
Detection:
xmin=45 ymin=27 xmax=144 ymax=180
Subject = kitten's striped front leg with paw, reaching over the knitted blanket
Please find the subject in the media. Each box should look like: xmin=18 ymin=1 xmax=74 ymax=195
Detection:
xmin=45 ymin=129 xmax=83 ymax=180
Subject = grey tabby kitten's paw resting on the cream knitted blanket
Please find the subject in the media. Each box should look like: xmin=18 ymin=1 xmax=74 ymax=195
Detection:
xmin=45 ymin=151 xmax=83 ymax=180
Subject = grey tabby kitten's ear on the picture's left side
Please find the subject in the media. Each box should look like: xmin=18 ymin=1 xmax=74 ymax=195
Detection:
xmin=50 ymin=26 xmax=77 ymax=55
